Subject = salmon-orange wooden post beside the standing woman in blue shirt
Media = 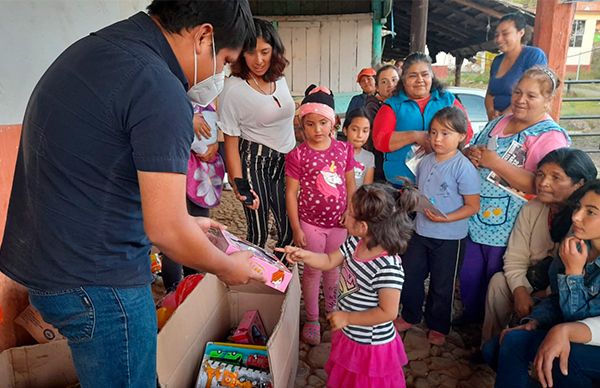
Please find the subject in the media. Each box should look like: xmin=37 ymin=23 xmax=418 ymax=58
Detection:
xmin=533 ymin=0 xmax=575 ymax=121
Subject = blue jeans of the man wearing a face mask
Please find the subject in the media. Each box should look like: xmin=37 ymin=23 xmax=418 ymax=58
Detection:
xmin=29 ymin=286 xmax=157 ymax=388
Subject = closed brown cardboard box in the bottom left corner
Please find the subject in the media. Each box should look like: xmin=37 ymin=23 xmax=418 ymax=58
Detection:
xmin=0 ymin=340 xmax=78 ymax=388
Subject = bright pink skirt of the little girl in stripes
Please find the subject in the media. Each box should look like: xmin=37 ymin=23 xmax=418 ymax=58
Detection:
xmin=325 ymin=330 xmax=408 ymax=388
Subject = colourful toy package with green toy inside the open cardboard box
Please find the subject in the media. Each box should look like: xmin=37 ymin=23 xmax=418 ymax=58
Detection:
xmin=196 ymin=342 xmax=273 ymax=388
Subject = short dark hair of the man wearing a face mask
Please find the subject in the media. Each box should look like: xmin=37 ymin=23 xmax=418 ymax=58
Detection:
xmin=147 ymin=0 xmax=256 ymax=51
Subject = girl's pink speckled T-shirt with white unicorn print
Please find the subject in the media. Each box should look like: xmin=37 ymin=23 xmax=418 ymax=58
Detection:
xmin=285 ymin=139 xmax=354 ymax=228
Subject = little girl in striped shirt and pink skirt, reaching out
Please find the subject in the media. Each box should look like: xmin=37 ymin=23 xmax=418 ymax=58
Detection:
xmin=282 ymin=183 xmax=417 ymax=388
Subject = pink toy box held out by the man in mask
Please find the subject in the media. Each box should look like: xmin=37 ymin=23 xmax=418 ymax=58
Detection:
xmin=211 ymin=228 xmax=292 ymax=292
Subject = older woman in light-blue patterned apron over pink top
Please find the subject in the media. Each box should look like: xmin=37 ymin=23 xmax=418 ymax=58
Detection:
xmin=460 ymin=66 xmax=570 ymax=322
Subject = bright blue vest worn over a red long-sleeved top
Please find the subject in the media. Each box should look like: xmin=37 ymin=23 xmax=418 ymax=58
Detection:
xmin=383 ymin=90 xmax=456 ymax=184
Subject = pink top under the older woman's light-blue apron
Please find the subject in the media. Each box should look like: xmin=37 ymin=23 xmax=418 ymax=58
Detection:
xmin=490 ymin=113 xmax=569 ymax=172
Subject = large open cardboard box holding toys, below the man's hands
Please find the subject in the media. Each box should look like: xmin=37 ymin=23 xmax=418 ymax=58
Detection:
xmin=157 ymin=269 xmax=300 ymax=388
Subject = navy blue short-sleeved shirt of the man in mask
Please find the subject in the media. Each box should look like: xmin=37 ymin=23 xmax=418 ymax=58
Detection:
xmin=0 ymin=12 xmax=193 ymax=291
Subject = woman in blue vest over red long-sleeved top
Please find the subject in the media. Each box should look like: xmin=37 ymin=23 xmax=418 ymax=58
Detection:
xmin=373 ymin=53 xmax=473 ymax=186
